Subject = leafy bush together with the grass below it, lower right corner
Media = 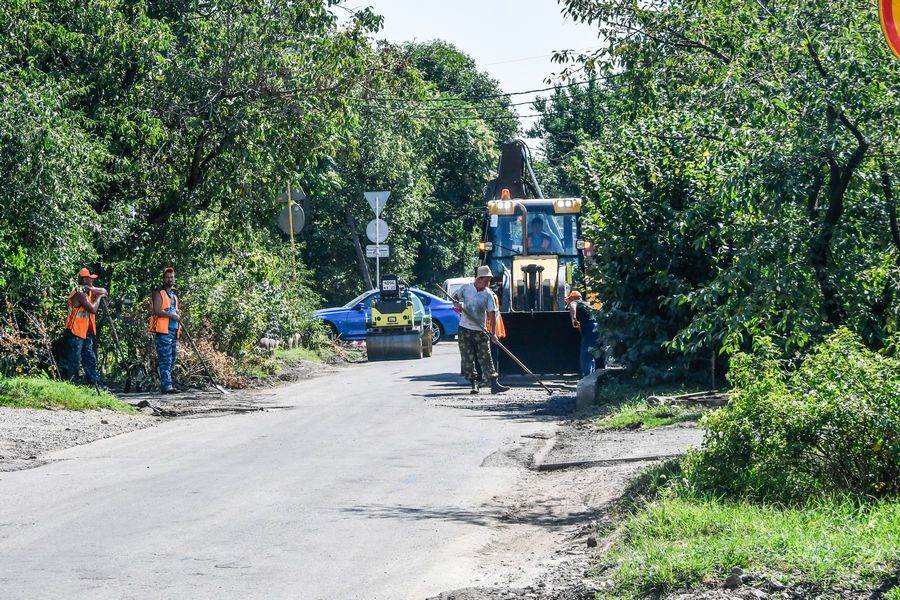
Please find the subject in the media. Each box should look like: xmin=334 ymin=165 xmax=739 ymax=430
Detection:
xmin=604 ymin=330 xmax=900 ymax=597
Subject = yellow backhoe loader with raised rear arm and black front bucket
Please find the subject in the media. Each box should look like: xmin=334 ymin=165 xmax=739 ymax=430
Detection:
xmin=479 ymin=140 xmax=599 ymax=375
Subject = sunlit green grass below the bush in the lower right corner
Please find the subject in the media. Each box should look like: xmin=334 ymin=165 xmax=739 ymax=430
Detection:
xmin=606 ymin=493 xmax=900 ymax=600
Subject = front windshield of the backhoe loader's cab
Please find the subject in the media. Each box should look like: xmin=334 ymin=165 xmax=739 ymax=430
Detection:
xmin=490 ymin=212 xmax=578 ymax=258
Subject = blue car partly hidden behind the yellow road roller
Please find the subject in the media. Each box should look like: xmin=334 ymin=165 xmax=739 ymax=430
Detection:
xmin=313 ymin=288 xmax=459 ymax=344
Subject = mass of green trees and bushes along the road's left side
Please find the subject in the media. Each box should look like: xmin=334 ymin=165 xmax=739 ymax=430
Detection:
xmin=0 ymin=0 xmax=519 ymax=396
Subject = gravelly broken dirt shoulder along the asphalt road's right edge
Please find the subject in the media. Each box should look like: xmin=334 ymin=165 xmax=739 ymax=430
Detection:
xmin=432 ymin=388 xmax=702 ymax=600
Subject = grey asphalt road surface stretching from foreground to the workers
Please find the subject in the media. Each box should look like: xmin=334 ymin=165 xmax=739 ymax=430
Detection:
xmin=0 ymin=343 xmax=553 ymax=599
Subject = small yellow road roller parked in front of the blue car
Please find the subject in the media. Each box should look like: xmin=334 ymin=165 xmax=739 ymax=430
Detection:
xmin=366 ymin=275 xmax=431 ymax=360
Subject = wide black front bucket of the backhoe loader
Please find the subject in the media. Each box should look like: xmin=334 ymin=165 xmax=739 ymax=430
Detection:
xmin=497 ymin=311 xmax=581 ymax=376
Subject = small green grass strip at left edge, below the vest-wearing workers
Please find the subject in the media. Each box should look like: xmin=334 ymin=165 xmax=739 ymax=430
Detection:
xmin=0 ymin=377 xmax=134 ymax=413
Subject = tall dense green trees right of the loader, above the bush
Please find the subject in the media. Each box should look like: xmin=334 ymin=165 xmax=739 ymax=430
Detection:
xmin=537 ymin=0 xmax=900 ymax=374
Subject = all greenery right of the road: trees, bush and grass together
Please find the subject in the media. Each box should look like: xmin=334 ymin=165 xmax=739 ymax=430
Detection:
xmin=532 ymin=0 xmax=900 ymax=597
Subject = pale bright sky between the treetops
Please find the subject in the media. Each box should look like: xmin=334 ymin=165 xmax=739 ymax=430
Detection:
xmin=345 ymin=0 xmax=600 ymax=130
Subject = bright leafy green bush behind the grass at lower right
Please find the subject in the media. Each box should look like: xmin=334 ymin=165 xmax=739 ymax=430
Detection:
xmin=684 ymin=329 xmax=900 ymax=503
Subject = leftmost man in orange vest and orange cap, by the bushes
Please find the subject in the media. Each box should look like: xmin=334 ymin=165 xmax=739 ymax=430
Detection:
xmin=65 ymin=268 xmax=108 ymax=386
